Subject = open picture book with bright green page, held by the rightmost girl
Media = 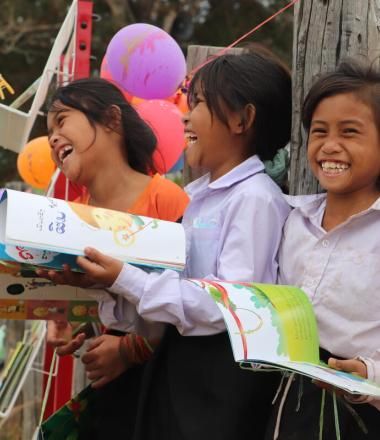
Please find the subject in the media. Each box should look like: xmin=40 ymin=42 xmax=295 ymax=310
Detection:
xmin=192 ymin=280 xmax=380 ymax=397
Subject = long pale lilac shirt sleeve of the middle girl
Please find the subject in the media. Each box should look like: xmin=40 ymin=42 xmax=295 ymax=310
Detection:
xmin=101 ymin=193 xmax=288 ymax=336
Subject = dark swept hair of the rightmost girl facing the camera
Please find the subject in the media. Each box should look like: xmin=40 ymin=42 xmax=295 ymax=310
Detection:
xmin=302 ymin=59 xmax=380 ymax=132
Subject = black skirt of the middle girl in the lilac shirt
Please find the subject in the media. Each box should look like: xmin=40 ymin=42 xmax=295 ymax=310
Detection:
xmin=133 ymin=326 xmax=280 ymax=440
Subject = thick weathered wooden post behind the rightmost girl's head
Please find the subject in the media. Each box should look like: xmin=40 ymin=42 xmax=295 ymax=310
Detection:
xmin=290 ymin=0 xmax=380 ymax=194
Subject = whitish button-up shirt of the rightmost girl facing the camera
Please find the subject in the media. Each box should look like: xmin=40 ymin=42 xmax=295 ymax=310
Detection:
xmin=279 ymin=195 xmax=380 ymax=409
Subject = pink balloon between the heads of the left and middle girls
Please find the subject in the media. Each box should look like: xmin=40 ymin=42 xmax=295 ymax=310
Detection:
xmin=136 ymin=99 xmax=185 ymax=174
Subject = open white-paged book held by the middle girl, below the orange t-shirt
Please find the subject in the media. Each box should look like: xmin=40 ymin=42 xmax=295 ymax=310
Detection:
xmin=0 ymin=190 xmax=185 ymax=270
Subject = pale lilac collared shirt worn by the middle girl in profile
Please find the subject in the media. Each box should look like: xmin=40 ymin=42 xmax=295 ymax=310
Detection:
xmin=100 ymin=156 xmax=290 ymax=335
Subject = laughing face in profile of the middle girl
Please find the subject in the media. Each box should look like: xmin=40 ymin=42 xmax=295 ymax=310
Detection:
xmin=184 ymin=84 xmax=246 ymax=180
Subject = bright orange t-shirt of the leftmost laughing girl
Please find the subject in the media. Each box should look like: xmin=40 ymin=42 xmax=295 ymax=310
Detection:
xmin=76 ymin=174 xmax=189 ymax=222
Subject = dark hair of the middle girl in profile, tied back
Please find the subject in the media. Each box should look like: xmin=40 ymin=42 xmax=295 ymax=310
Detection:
xmin=188 ymin=51 xmax=292 ymax=160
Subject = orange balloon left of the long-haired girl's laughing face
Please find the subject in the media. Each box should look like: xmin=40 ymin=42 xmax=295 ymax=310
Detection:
xmin=17 ymin=136 xmax=56 ymax=189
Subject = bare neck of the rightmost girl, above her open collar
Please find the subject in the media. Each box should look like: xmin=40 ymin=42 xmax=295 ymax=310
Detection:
xmin=322 ymin=191 xmax=380 ymax=231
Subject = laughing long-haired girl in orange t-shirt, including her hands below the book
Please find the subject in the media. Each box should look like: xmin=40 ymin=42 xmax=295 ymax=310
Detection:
xmin=47 ymin=78 xmax=188 ymax=439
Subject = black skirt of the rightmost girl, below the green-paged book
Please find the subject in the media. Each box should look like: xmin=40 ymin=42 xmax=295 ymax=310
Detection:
xmin=265 ymin=349 xmax=380 ymax=440
